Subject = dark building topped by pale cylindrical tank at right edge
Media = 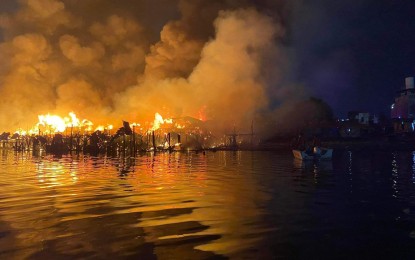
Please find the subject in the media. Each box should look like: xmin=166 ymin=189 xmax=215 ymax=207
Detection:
xmin=391 ymin=77 xmax=415 ymax=133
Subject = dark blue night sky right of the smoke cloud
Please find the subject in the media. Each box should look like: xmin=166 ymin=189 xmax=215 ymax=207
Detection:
xmin=0 ymin=0 xmax=415 ymax=117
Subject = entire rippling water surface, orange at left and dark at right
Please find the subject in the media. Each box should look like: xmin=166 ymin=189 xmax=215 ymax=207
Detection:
xmin=0 ymin=150 xmax=415 ymax=259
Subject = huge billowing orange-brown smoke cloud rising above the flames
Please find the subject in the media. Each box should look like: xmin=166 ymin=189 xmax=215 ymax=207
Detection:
xmin=0 ymin=0 xmax=326 ymax=137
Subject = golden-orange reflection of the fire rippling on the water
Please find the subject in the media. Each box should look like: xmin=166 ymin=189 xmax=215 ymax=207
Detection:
xmin=0 ymin=152 xmax=267 ymax=257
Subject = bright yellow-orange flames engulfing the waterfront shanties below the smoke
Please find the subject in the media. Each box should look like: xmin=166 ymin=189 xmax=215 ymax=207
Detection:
xmin=7 ymin=109 xmax=228 ymax=152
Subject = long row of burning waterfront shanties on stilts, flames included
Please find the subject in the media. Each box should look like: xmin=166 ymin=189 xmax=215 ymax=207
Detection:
xmin=0 ymin=112 xmax=253 ymax=155
